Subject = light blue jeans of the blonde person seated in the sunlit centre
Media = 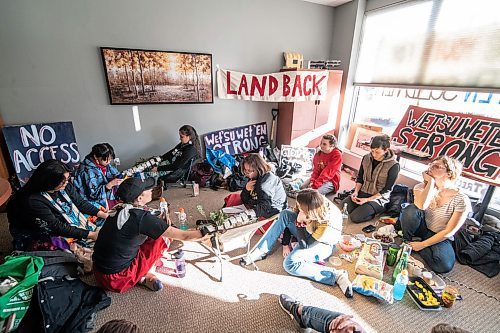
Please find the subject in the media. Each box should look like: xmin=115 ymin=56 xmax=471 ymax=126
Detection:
xmin=254 ymin=209 xmax=337 ymax=285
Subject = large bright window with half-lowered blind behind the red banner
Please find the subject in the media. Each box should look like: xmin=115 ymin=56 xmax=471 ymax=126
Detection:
xmin=351 ymin=0 xmax=500 ymax=212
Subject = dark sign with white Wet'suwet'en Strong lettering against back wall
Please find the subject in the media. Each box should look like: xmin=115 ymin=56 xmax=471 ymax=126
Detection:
xmin=204 ymin=122 xmax=269 ymax=155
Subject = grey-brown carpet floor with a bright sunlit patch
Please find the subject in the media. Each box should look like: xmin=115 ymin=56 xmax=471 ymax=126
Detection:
xmin=0 ymin=180 xmax=500 ymax=333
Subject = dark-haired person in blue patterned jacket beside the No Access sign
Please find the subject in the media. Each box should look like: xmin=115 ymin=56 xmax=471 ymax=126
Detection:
xmin=73 ymin=143 xmax=122 ymax=210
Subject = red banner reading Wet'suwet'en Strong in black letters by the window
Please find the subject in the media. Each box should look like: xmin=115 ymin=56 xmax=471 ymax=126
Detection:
xmin=392 ymin=105 xmax=500 ymax=186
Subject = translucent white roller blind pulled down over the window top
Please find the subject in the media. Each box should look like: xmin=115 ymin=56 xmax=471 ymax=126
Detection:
xmin=354 ymin=0 xmax=500 ymax=89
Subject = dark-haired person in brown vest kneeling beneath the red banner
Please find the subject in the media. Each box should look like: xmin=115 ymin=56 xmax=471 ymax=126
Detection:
xmin=342 ymin=135 xmax=399 ymax=223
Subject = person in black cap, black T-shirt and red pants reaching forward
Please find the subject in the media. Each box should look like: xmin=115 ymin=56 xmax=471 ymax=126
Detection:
xmin=92 ymin=178 xmax=207 ymax=293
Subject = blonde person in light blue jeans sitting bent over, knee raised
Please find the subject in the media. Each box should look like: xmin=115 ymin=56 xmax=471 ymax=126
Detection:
xmin=240 ymin=189 xmax=352 ymax=297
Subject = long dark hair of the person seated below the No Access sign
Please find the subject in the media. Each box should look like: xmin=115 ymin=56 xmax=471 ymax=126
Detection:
xmin=19 ymin=160 xmax=71 ymax=193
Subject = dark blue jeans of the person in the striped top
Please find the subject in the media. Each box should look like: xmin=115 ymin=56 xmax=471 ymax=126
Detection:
xmin=399 ymin=204 xmax=455 ymax=273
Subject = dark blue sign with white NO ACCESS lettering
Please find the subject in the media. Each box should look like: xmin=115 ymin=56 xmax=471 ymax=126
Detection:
xmin=3 ymin=121 xmax=80 ymax=185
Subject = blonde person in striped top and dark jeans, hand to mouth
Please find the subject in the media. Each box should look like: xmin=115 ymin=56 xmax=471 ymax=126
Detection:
xmin=400 ymin=156 xmax=472 ymax=273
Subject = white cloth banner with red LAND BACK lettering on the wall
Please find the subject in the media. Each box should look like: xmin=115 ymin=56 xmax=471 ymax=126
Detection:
xmin=217 ymin=69 xmax=328 ymax=102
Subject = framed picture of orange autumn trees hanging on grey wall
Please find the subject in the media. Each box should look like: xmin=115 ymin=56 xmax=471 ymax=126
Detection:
xmin=101 ymin=47 xmax=213 ymax=105
